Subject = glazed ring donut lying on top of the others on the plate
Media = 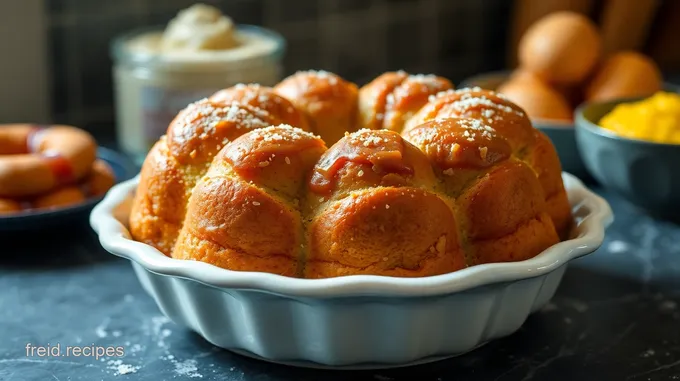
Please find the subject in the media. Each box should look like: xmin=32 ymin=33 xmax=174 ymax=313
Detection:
xmin=0 ymin=124 xmax=97 ymax=198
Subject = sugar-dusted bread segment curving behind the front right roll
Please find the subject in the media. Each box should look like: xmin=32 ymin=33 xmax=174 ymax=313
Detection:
xmin=404 ymin=88 xmax=572 ymax=238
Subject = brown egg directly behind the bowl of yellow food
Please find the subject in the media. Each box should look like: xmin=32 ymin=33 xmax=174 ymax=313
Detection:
xmin=586 ymin=51 xmax=663 ymax=101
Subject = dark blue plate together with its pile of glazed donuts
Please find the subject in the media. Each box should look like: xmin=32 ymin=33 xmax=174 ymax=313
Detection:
xmin=0 ymin=124 xmax=137 ymax=231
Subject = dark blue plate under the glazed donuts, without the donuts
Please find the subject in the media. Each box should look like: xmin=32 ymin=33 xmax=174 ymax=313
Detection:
xmin=0 ymin=147 xmax=138 ymax=232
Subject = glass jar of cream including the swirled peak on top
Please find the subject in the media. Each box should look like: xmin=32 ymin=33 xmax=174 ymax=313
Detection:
xmin=112 ymin=4 xmax=285 ymax=163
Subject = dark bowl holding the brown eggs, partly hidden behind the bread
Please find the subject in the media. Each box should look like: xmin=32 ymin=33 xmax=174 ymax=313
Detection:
xmin=458 ymin=71 xmax=592 ymax=181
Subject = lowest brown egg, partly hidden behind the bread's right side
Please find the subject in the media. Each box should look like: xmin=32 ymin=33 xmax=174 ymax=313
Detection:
xmin=498 ymin=73 xmax=572 ymax=120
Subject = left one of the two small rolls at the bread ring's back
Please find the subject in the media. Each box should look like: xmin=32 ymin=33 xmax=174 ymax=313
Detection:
xmin=274 ymin=70 xmax=358 ymax=145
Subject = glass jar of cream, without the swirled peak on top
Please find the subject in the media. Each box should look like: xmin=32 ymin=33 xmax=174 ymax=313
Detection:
xmin=112 ymin=25 xmax=285 ymax=164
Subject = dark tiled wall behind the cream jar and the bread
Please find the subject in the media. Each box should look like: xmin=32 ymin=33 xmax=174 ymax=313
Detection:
xmin=44 ymin=0 xmax=511 ymax=140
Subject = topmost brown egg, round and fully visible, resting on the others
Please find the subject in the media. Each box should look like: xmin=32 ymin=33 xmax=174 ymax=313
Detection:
xmin=518 ymin=12 xmax=602 ymax=84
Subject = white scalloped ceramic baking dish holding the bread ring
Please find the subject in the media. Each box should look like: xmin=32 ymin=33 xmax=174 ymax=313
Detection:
xmin=90 ymin=173 xmax=613 ymax=368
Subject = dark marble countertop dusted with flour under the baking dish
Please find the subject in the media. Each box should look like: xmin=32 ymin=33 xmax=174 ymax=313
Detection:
xmin=0 ymin=183 xmax=680 ymax=381
